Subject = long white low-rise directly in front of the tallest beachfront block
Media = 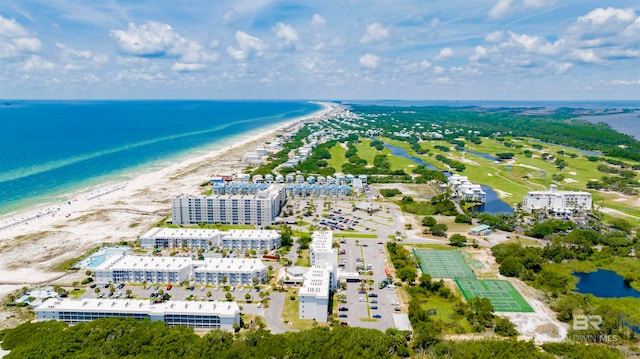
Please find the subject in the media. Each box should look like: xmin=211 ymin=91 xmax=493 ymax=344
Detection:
xmin=140 ymin=228 xmax=281 ymax=251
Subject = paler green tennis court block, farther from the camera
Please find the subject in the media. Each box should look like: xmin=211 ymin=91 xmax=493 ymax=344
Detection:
xmin=413 ymin=249 xmax=476 ymax=279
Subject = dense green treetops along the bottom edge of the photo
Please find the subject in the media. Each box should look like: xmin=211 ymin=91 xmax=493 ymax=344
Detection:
xmin=0 ymin=318 xmax=623 ymax=359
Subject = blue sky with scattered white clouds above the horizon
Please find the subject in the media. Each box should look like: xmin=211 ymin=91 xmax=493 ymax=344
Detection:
xmin=0 ymin=0 xmax=640 ymax=101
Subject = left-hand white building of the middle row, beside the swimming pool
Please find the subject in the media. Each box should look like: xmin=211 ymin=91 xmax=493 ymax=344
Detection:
xmin=93 ymin=255 xmax=193 ymax=284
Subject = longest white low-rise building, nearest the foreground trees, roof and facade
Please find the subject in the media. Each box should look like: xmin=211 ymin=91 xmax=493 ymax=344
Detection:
xmin=34 ymin=298 xmax=240 ymax=331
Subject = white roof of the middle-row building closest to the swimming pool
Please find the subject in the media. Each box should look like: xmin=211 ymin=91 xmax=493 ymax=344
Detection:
xmin=95 ymin=256 xmax=192 ymax=270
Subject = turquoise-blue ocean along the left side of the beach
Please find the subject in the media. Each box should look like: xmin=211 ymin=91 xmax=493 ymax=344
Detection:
xmin=0 ymin=101 xmax=321 ymax=214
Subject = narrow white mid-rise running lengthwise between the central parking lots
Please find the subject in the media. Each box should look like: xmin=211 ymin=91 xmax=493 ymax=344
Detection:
xmin=298 ymin=231 xmax=338 ymax=322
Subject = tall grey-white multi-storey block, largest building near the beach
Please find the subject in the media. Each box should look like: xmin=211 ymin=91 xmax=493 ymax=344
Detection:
xmin=171 ymin=184 xmax=286 ymax=226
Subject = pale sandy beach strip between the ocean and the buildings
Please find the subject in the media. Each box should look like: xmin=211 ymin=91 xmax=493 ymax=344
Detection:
xmin=0 ymin=103 xmax=342 ymax=296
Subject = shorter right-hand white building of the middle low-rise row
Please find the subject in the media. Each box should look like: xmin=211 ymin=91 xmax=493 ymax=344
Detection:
xmin=193 ymin=258 xmax=267 ymax=286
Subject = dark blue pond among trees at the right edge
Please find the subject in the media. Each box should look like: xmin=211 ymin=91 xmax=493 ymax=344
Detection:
xmin=572 ymin=269 xmax=640 ymax=298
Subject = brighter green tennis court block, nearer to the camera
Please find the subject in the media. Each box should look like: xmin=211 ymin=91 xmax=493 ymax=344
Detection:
xmin=456 ymin=279 xmax=533 ymax=312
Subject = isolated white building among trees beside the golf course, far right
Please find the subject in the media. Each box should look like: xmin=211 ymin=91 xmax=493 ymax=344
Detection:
xmin=523 ymin=185 xmax=592 ymax=214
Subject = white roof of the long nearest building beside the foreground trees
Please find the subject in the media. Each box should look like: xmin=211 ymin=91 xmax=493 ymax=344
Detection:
xmin=35 ymin=298 xmax=240 ymax=317
